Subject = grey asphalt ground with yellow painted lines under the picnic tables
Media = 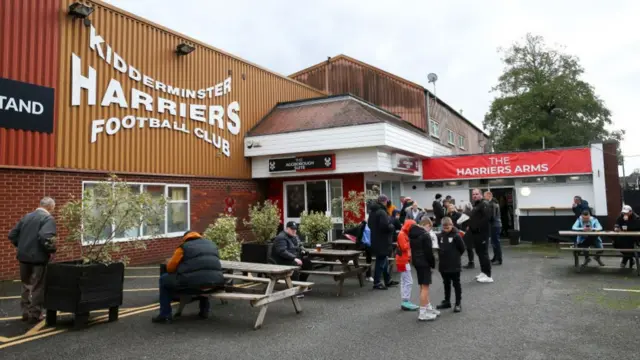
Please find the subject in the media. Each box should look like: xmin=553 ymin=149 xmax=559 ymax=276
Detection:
xmin=0 ymin=245 xmax=640 ymax=360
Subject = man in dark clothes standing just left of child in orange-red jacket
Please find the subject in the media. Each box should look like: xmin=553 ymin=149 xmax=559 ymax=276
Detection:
xmin=367 ymin=195 xmax=398 ymax=290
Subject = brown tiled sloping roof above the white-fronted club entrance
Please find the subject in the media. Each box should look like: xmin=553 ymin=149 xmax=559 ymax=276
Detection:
xmin=247 ymin=94 xmax=425 ymax=136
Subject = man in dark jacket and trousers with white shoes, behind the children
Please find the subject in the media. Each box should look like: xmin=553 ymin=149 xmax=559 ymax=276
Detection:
xmin=465 ymin=189 xmax=493 ymax=283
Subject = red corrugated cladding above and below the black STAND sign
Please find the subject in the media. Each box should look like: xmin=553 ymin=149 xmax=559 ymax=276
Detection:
xmin=0 ymin=0 xmax=60 ymax=167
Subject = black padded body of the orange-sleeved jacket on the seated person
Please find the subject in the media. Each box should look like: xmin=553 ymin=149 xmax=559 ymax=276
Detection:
xmin=176 ymin=238 xmax=225 ymax=287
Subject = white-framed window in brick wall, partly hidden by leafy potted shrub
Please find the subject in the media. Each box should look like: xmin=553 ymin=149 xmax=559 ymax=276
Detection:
xmin=83 ymin=182 xmax=190 ymax=241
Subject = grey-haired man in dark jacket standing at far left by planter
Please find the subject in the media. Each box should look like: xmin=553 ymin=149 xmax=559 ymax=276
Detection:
xmin=9 ymin=197 xmax=56 ymax=322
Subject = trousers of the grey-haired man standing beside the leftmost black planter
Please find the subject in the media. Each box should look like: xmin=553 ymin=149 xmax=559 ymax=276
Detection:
xmin=20 ymin=263 xmax=47 ymax=318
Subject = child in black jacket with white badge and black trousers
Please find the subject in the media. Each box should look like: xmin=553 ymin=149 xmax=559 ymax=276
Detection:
xmin=436 ymin=217 xmax=465 ymax=312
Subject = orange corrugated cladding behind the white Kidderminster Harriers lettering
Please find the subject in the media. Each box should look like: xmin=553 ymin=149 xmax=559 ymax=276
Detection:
xmin=56 ymin=0 xmax=324 ymax=179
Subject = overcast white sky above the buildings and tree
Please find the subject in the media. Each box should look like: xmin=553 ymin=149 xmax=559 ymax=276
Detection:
xmin=108 ymin=0 xmax=640 ymax=173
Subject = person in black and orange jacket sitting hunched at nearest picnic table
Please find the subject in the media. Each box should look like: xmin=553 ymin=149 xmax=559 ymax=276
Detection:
xmin=152 ymin=231 xmax=225 ymax=323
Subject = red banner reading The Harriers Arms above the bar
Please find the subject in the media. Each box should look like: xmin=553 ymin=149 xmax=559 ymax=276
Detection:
xmin=422 ymin=148 xmax=591 ymax=180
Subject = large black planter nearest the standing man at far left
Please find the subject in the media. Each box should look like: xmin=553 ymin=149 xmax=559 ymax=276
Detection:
xmin=44 ymin=261 xmax=124 ymax=328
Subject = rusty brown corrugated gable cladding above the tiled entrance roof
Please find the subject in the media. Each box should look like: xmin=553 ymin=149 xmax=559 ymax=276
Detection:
xmin=291 ymin=55 xmax=427 ymax=130
